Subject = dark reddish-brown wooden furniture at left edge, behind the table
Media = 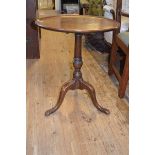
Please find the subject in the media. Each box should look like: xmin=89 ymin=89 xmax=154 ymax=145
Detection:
xmin=26 ymin=0 xmax=40 ymax=59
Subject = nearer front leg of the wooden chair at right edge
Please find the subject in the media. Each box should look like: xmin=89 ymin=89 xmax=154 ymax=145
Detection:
xmin=118 ymin=55 xmax=129 ymax=98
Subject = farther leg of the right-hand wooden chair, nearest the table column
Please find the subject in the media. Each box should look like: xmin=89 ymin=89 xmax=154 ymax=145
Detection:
xmin=108 ymin=37 xmax=118 ymax=75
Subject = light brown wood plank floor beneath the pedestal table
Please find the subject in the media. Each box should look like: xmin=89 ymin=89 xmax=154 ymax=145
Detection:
xmin=27 ymin=30 xmax=129 ymax=155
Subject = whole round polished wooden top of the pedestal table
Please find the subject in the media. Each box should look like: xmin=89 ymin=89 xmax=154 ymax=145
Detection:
xmin=35 ymin=15 xmax=120 ymax=33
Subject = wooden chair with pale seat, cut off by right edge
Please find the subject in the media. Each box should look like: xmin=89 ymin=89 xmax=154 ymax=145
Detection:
xmin=109 ymin=0 xmax=129 ymax=98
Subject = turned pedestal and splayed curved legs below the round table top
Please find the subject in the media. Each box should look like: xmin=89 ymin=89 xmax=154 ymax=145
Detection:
xmin=45 ymin=34 xmax=110 ymax=116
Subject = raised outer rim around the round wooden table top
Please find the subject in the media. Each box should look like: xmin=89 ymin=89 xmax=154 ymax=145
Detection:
xmin=35 ymin=14 xmax=120 ymax=33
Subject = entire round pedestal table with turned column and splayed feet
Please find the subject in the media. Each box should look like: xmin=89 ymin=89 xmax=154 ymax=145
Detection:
xmin=35 ymin=15 xmax=120 ymax=116
